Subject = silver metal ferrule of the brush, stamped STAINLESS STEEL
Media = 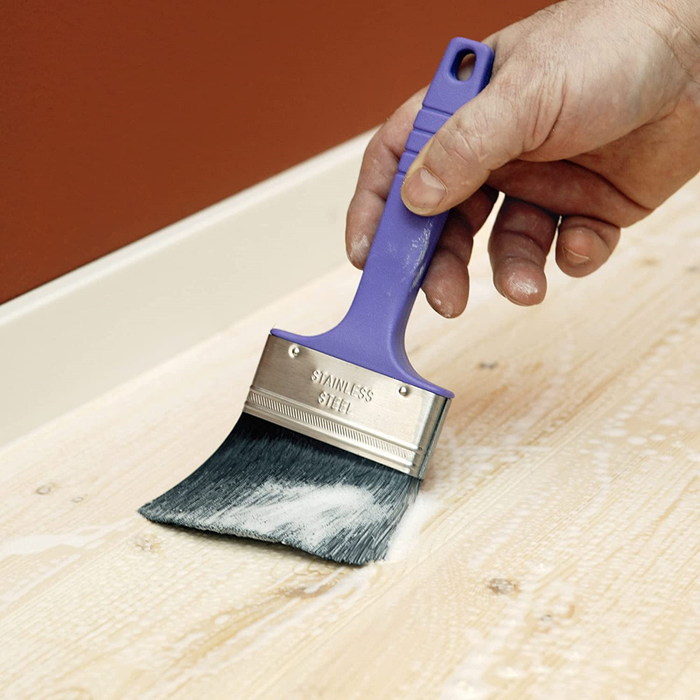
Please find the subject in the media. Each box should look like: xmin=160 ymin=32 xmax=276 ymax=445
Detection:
xmin=243 ymin=335 xmax=450 ymax=478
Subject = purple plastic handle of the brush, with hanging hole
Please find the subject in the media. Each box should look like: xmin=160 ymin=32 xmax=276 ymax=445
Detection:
xmin=272 ymin=37 xmax=494 ymax=398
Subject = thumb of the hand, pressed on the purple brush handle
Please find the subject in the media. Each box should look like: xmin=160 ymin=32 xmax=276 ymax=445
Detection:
xmin=401 ymin=72 xmax=541 ymax=216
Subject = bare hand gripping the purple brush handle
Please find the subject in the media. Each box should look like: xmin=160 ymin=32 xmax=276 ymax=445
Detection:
xmin=346 ymin=0 xmax=700 ymax=317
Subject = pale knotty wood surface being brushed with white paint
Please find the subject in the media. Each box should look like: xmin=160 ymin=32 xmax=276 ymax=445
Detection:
xmin=0 ymin=179 xmax=700 ymax=700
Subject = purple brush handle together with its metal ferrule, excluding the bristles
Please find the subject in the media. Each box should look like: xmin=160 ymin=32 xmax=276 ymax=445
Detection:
xmin=244 ymin=37 xmax=494 ymax=478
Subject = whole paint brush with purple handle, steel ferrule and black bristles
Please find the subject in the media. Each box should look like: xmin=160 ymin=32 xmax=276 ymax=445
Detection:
xmin=139 ymin=38 xmax=493 ymax=564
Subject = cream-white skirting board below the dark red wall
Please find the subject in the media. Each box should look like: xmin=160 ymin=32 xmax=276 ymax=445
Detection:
xmin=0 ymin=133 xmax=378 ymax=446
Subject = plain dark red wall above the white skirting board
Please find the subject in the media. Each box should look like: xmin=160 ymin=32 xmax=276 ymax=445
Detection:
xmin=0 ymin=0 xmax=548 ymax=302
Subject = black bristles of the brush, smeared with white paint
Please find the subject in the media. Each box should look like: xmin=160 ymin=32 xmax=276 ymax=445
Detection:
xmin=139 ymin=413 xmax=420 ymax=564
